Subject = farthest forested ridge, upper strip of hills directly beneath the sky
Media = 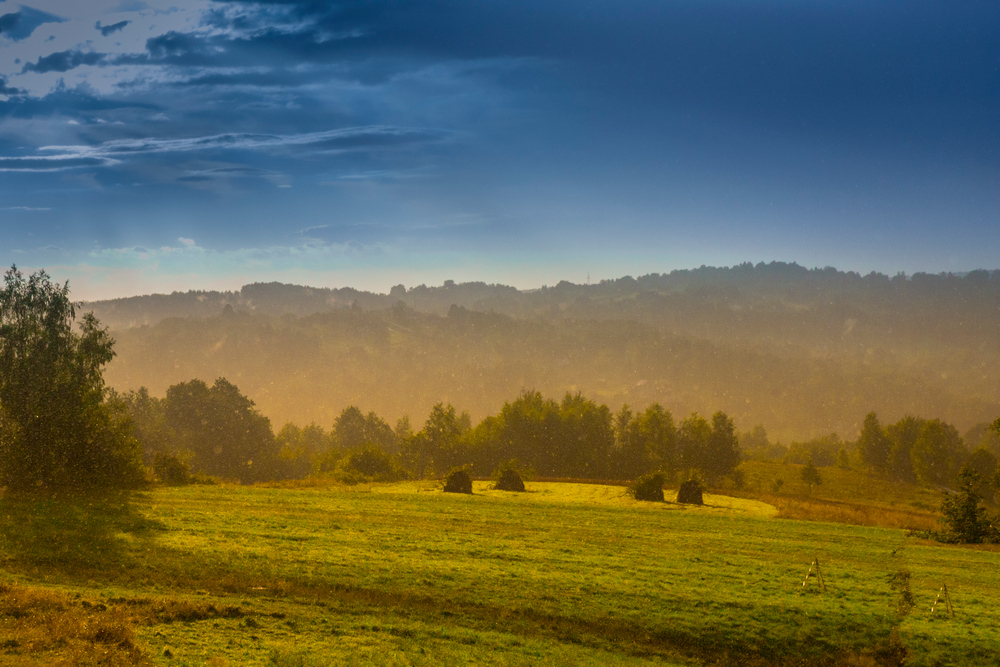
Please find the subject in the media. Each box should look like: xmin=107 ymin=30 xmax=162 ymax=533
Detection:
xmin=85 ymin=262 xmax=1000 ymax=339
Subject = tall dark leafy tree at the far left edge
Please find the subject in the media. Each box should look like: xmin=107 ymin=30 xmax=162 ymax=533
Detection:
xmin=0 ymin=267 xmax=143 ymax=491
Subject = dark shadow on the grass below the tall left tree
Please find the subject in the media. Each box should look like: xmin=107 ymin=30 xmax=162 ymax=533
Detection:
xmin=0 ymin=491 xmax=165 ymax=577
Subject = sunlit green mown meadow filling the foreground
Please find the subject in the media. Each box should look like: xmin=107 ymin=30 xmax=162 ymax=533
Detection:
xmin=0 ymin=482 xmax=1000 ymax=667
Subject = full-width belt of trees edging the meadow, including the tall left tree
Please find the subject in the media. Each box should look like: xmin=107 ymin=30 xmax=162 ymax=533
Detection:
xmin=0 ymin=267 xmax=1000 ymax=498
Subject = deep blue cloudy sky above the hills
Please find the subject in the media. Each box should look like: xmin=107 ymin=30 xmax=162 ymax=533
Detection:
xmin=0 ymin=0 xmax=1000 ymax=300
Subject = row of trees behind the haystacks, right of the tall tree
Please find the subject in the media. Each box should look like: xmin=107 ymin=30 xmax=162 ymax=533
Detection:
xmin=114 ymin=378 xmax=740 ymax=483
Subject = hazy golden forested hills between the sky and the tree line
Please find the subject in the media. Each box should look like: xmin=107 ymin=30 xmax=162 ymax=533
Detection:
xmin=85 ymin=263 xmax=1000 ymax=441
